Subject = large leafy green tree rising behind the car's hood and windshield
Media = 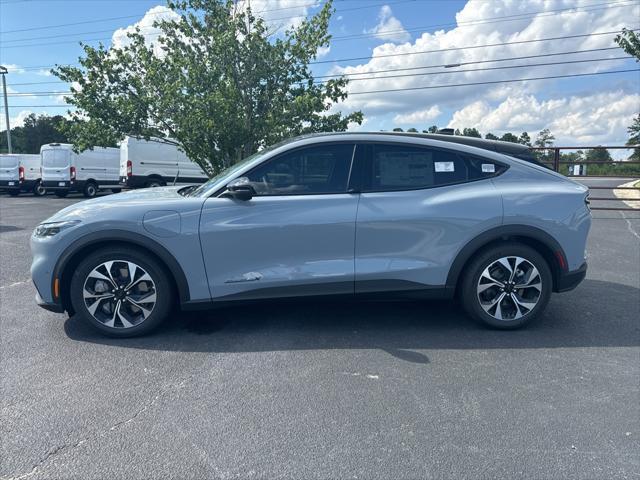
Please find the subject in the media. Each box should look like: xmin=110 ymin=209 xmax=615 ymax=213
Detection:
xmin=53 ymin=0 xmax=363 ymax=174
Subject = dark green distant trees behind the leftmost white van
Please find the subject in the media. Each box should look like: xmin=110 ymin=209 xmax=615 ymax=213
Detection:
xmin=0 ymin=113 xmax=77 ymax=153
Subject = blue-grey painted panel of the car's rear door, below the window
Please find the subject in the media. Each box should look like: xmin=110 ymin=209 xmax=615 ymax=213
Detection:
xmin=355 ymin=179 xmax=502 ymax=293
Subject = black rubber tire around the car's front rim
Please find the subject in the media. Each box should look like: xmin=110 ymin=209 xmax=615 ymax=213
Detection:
xmin=70 ymin=247 xmax=174 ymax=338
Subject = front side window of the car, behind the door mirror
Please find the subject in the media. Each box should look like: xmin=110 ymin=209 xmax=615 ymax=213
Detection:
xmin=246 ymin=143 xmax=354 ymax=196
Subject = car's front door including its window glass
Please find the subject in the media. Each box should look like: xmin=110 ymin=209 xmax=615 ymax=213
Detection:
xmin=200 ymin=143 xmax=358 ymax=300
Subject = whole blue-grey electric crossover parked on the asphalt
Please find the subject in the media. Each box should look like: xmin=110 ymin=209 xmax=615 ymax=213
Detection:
xmin=31 ymin=133 xmax=591 ymax=337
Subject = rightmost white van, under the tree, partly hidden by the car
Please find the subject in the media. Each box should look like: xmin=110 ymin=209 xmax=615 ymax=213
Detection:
xmin=120 ymin=137 xmax=209 ymax=188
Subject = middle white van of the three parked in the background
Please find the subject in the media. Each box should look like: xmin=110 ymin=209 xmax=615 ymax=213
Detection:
xmin=40 ymin=143 xmax=121 ymax=197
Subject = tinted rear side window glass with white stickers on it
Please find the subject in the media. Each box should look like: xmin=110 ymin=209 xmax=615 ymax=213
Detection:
xmin=364 ymin=145 xmax=504 ymax=191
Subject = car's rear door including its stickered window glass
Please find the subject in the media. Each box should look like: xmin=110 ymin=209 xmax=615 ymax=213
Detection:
xmin=355 ymin=143 xmax=502 ymax=293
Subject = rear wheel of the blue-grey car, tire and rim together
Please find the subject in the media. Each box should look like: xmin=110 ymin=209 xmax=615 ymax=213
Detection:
xmin=461 ymin=243 xmax=553 ymax=329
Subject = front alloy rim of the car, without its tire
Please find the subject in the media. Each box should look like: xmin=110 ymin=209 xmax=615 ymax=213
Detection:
xmin=82 ymin=260 xmax=156 ymax=328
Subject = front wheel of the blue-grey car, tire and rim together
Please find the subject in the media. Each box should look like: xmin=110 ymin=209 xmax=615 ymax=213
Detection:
xmin=70 ymin=248 xmax=173 ymax=337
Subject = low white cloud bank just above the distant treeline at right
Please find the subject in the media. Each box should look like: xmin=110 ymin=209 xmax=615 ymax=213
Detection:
xmin=448 ymin=91 xmax=640 ymax=145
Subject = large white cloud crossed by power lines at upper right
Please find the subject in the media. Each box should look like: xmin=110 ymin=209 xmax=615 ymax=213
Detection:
xmin=330 ymin=0 xmax=640 ymax=116
